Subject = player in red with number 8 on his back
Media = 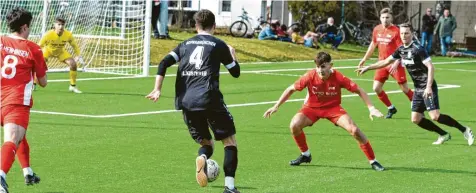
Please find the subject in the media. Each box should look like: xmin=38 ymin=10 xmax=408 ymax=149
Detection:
xmin=0 ymin=8 xmax=47 ymax=192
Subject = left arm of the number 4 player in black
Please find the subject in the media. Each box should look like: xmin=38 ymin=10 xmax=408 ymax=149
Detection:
xmin=145 ymin=51 xmax=178 ymax=102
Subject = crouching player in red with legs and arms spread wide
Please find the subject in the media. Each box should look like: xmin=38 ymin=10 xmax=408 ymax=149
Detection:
xmin=264 ymin=52 xmax=384 ymax=171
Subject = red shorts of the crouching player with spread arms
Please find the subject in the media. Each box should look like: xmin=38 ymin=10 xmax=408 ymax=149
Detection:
xmin=299 ymin=105 xmax=347 ymax=124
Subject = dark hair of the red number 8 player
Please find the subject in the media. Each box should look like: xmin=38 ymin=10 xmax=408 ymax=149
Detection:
xmin=7 ymin=7 xmax=33 ymax=32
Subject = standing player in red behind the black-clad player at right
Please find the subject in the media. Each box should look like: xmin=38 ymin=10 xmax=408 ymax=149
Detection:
xmin=358 ymin=8 xmax=413 ymax=119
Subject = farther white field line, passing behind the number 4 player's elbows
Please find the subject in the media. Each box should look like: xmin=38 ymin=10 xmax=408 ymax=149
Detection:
xmin=48 ymin=59 xmax=476 ymax=82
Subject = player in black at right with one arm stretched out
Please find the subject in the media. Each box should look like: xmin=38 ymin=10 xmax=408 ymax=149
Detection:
xmin=356 ymin=24 xmax=474 ymax=145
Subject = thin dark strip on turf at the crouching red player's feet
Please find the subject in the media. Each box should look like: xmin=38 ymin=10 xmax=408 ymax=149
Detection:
xmin=299 ymin=164 xmax=476 ymax=176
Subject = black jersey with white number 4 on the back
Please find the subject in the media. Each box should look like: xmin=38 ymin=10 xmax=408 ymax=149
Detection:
xmin=170 ymin=34 xmax=238 ymax=111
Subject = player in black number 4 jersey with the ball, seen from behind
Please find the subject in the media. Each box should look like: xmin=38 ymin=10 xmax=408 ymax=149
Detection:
xmin=146 ymin=10 xmax=240 ymax=193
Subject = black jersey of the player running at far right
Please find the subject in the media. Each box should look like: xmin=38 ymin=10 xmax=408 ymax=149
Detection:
xmin=392 ymin=42 xmax=437 ymax=91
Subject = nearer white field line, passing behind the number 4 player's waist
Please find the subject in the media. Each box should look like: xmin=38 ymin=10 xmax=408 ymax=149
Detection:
xmin=31 ymin=82 xmax=461 ymax=118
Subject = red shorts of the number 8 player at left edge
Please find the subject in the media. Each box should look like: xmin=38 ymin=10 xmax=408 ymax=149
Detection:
xmin=1 ymin=105 xmax=30 ymax=129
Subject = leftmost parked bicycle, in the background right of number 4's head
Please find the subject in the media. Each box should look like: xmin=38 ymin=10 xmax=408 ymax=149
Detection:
xmin=229 ymin=8 xmax=269 ymax=37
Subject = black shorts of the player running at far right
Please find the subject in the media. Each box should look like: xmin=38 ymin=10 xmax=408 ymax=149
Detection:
xmin=412 ymin=88 xmax=440 ymax=113
